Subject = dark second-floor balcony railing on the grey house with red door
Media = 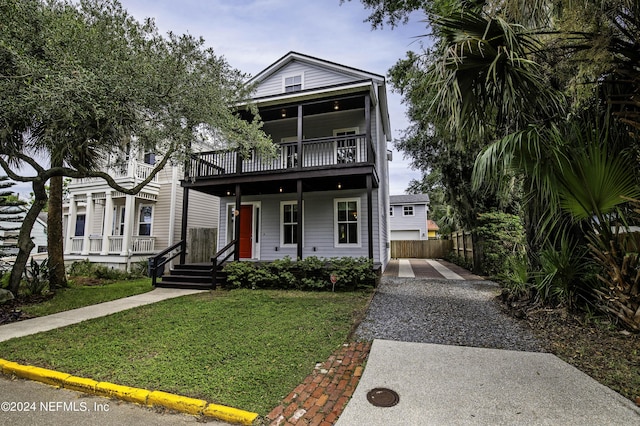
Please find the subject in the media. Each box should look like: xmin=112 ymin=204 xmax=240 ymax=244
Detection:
xmin=186 ymin=134 xmax=375 ymax=178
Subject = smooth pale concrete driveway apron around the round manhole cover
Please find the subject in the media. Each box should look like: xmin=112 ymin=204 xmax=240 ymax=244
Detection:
xmin=336 ymin=340 xmax=640 ymax=426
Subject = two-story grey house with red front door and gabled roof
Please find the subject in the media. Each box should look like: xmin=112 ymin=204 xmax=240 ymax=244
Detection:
xmin=182 ymin=52 xmax=391 ymax=267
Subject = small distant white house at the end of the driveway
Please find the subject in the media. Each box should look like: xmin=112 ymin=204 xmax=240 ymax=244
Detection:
xmin=389 ymin=194 xmax=429 ymax=241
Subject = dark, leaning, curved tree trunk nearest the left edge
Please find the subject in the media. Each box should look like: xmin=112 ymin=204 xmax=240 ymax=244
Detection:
xmin=9 ymin=181 xmax=47 ymax=295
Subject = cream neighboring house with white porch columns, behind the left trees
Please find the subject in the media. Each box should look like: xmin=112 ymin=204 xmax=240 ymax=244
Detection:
xmin=63 ymin=145 xmax=219 ymax=269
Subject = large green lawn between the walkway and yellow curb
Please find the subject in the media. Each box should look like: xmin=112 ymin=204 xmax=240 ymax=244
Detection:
xmin=0 ymin=290 xmax=371 ymax=415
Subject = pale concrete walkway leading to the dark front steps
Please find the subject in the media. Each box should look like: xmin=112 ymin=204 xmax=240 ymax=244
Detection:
xmin=0 ymin=288 xmax=202 ymax=342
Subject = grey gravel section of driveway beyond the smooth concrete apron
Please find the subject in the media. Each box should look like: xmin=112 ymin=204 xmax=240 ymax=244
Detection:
xmin=356 ymin=277 xmax=543 ymax=352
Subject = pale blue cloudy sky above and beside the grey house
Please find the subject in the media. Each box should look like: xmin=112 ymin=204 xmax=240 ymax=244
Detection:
xmin=121 ymin=0 xmax=426 ymax=194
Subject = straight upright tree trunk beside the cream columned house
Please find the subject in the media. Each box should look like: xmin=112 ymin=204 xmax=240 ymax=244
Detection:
xmin=47 ymin=176 xmax=67 ymax=290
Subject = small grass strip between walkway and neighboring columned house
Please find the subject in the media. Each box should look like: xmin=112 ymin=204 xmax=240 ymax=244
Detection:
xmin=21 ymin=278 xmax=153 ymax=317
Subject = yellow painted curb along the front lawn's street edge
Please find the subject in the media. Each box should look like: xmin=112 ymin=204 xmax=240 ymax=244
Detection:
xmin=0 ymin=359 xmax=258 ymax=425
